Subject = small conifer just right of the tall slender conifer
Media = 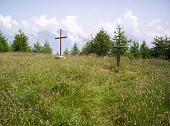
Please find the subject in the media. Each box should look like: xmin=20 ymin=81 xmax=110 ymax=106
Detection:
xmin=130 ymin=40 xmax=140 ymax=58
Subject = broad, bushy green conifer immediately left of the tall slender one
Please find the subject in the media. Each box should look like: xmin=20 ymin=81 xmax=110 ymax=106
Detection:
xmin=93 ymin=29 xmax=111 ymax=56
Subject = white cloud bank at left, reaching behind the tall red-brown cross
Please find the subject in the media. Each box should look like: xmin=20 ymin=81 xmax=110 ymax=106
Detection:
xmin=0 ymin=15 xmax=87 ymax=44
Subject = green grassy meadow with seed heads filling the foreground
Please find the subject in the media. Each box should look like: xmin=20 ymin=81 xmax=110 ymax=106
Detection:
xmin=0 ymin=53 xmax=170 ymax=126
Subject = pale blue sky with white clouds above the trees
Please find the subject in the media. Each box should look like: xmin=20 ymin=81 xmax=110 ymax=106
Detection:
xmin=0 ymin=0 xmax=170 ymax=50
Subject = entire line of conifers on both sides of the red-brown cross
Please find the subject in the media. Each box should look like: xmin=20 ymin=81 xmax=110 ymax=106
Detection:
xmin=0 ymin=25 xmax=170 ymax=59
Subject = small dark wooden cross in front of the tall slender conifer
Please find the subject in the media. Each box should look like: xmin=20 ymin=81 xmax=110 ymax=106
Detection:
xmin=113 ymin=39 xmax=126 ymax=66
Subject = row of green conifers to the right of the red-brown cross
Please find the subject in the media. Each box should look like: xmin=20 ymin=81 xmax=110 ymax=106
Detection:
xmin=64 ymin=25 xmax=170 ymax=59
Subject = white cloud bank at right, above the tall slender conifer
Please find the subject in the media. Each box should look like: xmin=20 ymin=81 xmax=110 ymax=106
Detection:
xmin=99 ymin=9 xmax=170 ymax=44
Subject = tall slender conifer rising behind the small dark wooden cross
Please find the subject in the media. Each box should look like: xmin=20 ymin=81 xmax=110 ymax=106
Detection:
xmin=112 ymin=25 xmax=128 ymax=54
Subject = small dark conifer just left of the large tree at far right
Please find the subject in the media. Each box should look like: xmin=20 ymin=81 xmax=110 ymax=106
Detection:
xmin=140 ymin=41 xmax=150 ymax=59
